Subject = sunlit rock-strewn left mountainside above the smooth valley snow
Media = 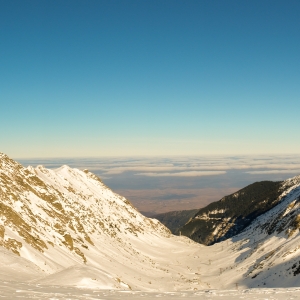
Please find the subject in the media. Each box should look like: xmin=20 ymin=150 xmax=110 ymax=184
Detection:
xmin=0 ymin=154 xmax=169 ymax=262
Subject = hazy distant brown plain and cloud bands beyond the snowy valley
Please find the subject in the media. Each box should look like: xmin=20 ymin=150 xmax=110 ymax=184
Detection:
xmin=17 ymin=155 xmax=300 ymax=216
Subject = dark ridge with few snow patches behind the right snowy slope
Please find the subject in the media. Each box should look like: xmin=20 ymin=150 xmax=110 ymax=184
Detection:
xmin=179 ymin=181 xmax=298 ymax=245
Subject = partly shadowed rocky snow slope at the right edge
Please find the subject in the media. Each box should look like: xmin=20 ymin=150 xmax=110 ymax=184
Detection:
xmin=230 ymin=176 xmax=300 ymax=287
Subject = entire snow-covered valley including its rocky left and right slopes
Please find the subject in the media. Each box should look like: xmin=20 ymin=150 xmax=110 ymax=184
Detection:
xmin=0 ymin=150 xmax=300 ymax=293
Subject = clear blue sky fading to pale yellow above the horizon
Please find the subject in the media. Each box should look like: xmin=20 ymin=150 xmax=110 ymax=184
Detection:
xmin=0 ymin=0 xmax=300 ymax=158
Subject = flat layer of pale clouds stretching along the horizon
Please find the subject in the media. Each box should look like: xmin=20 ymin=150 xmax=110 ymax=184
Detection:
xmin=20 ymin=155 xmax=300 ymax=177
